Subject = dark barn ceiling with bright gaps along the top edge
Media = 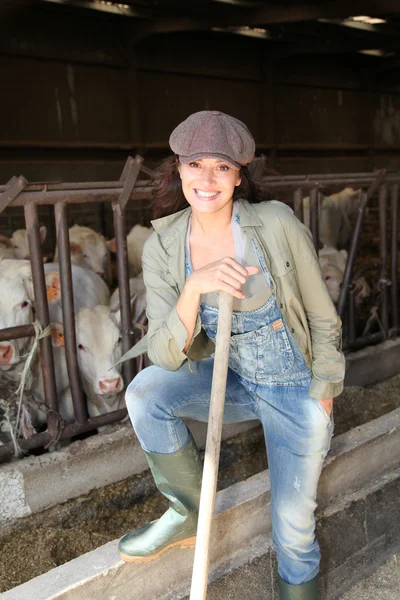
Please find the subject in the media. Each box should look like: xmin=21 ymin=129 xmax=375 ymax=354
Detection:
xmin=34 ymin=0 xmax=400 ymax=59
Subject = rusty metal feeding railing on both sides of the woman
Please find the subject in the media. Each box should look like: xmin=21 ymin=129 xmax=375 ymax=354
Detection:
xmin=0 ymin=166 xmax=400 ymax=461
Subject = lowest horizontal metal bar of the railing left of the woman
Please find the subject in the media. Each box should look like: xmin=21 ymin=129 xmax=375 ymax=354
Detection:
xmin=0 ymin=408 xmax=127 ymax=462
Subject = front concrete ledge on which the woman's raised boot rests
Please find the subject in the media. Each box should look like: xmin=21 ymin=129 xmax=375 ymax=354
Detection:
xmin=3 ymin=409 xmax=400 ymax=600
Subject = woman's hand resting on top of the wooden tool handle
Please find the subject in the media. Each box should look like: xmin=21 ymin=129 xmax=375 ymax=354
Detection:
xmin=185 ymin=257 xmax=259 ymax=300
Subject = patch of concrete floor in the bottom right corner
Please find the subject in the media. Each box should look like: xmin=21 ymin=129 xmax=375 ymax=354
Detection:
xmin=340 ymin=553 xmax=400 ymax=600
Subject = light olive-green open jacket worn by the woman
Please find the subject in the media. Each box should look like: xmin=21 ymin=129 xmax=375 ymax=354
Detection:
xmin=122 ymin=200 xmax=345 ymax=399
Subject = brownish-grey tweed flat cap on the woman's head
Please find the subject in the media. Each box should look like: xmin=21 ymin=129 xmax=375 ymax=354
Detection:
xmin=169 ymin=110 xmax=255 ymax=169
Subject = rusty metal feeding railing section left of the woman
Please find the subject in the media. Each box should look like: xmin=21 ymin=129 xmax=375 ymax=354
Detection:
xmin=0 ymin=156 xmax=154 ymax=461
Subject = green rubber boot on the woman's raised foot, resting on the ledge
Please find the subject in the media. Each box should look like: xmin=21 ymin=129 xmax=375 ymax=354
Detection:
xmin=118 ymin=438 xmax=203 ymax=562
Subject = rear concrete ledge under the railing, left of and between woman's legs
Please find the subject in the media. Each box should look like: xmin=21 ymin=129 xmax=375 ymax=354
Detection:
xmin=0 ymin=419 xmax=258 ymax=532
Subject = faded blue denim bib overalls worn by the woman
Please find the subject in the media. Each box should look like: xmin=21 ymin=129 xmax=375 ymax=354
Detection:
xmin=126 ymin=219 xmax=333 ymax=585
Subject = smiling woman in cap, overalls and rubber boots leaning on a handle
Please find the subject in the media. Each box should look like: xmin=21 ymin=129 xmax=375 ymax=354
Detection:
xmin=119 ymin=111 xmax=344 ymax=600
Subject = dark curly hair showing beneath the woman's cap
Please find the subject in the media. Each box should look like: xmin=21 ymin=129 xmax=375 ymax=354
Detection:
xmin=152 ymin=155 xmax=272 ymax=219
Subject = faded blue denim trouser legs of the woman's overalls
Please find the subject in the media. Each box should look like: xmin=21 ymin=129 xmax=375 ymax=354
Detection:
xmin=126 ymin=358 xmax=333 ymax=585
